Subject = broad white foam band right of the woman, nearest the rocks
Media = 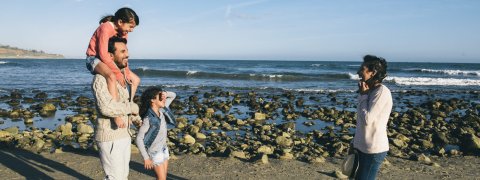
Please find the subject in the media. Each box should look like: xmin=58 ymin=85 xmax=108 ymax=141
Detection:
xmin=385 ymin=77 xmax=480 ymax=86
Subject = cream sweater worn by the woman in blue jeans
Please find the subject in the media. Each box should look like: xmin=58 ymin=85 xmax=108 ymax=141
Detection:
xmin=353 ymin=85 xmax=393 ymax=154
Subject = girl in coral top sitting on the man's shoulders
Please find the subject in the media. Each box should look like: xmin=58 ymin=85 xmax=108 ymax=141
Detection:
xmin=86 ymin=8 xmax=140 ymax=101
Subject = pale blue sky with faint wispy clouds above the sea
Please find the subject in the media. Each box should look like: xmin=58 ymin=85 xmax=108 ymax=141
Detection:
xmin=0 ymin=0 xmax=480 ymax=63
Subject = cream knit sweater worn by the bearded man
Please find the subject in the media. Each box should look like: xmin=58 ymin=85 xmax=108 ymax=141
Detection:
xmin=92 ymin=74 xmax=140 ymax=142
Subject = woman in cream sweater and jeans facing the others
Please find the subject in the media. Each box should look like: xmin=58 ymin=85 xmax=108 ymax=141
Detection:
xmin=353 ymin=55 xmax=393 ymax=180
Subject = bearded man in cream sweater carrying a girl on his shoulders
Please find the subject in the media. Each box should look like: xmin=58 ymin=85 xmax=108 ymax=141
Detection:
xmin=92 ymin=37 xmax=139 ymax=179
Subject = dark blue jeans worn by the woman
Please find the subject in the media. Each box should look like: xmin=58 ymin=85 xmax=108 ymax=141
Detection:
xmin=355 ymin=151 xmax=387 ymax=180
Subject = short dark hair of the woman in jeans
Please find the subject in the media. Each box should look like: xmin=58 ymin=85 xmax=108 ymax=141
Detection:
xmin=363 ymin=55 xmax=387 ymax=82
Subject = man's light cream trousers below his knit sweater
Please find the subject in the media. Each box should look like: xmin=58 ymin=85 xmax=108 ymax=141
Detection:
xmin=97 ymin=137 xmax=132 ymax=179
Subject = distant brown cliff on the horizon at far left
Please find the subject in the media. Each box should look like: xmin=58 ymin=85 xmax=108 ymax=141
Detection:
xmin=0 ymin=45 xmax=64 ymax=59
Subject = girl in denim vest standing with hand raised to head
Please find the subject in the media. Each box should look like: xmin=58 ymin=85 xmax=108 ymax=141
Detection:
xmin=136 ymin=87 xmax=176 ymax=179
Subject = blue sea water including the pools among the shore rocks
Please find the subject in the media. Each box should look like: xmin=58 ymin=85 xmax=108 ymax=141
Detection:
xmin=0 ymin=59 xmax=480 ymax=131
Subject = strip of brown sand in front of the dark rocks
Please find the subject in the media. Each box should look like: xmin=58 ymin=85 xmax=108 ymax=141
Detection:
xmin=0 ymin=149 xmax=480 ymax=180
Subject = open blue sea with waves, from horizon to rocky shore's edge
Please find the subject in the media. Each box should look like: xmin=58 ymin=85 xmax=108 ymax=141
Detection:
xmin=0 ymin=59 xmax=480 ymax=92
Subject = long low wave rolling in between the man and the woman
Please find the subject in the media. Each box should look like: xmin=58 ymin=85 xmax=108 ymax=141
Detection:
xmin=133 ymin=68 xmax=351 ymax=81
